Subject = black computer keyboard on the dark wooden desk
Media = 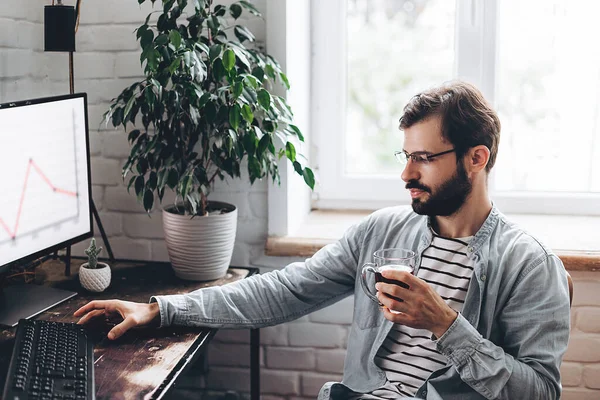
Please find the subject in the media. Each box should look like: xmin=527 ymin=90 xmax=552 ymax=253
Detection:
xmin=2 ymin=319 xmax=95 ymax=400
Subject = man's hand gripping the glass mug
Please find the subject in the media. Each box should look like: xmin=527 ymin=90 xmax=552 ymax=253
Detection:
xmin=375 ymin=270 xmax=458 ymax=338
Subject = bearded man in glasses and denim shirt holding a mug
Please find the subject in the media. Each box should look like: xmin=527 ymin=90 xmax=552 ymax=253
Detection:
xmin=75 ymin=82 xmax=570 ymax=400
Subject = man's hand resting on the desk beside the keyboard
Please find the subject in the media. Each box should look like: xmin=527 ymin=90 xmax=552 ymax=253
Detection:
xmin=73 ymin=300 xmax=160 ymax=340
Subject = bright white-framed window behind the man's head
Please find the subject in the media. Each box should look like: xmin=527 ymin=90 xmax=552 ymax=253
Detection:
xmin=311 ymin=0 xmax=600 ymax=215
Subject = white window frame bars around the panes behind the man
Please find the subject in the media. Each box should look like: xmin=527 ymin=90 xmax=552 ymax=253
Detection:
xmin=311 ymin=0 xmax=600 ymax=215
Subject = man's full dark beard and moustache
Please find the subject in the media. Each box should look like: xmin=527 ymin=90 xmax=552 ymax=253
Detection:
xmin=406 ymin=162 xmax=473 ymax=217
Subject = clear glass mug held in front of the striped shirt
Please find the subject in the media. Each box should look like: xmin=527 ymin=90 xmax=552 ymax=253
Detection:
xmin=360 ymin=249 xmax=416 ymax=313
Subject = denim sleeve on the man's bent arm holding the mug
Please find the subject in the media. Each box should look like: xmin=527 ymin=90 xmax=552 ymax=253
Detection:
xmin=437 ymin=255 xmax=570 ymax=400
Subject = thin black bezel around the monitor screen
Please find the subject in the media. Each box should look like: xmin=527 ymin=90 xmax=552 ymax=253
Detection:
xmin=0 ymin=93 xmax=94 ymax=274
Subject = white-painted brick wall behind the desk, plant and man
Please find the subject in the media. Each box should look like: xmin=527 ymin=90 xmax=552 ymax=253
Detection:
xmin=0 ymin=0 xmax=600 ymax=400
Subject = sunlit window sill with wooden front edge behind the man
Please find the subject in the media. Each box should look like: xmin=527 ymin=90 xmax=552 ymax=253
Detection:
xmin=265 ymin=210 xmax=600 ymax=271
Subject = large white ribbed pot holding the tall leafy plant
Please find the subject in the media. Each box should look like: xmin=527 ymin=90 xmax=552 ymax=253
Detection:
xmin=163 ymin=201 xmax=238 ymax=281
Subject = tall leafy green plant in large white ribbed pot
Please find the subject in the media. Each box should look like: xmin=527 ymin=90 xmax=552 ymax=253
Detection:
xmin=105 ymin=0 xmax=315 ymax=280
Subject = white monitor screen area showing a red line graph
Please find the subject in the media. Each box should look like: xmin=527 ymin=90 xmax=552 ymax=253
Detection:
xmin=0 ymin=103 xmax=89 ymax=253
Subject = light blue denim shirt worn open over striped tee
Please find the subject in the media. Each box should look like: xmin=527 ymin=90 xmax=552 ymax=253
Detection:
xmin=152 ymin=206 xmax=570 ymax=400
